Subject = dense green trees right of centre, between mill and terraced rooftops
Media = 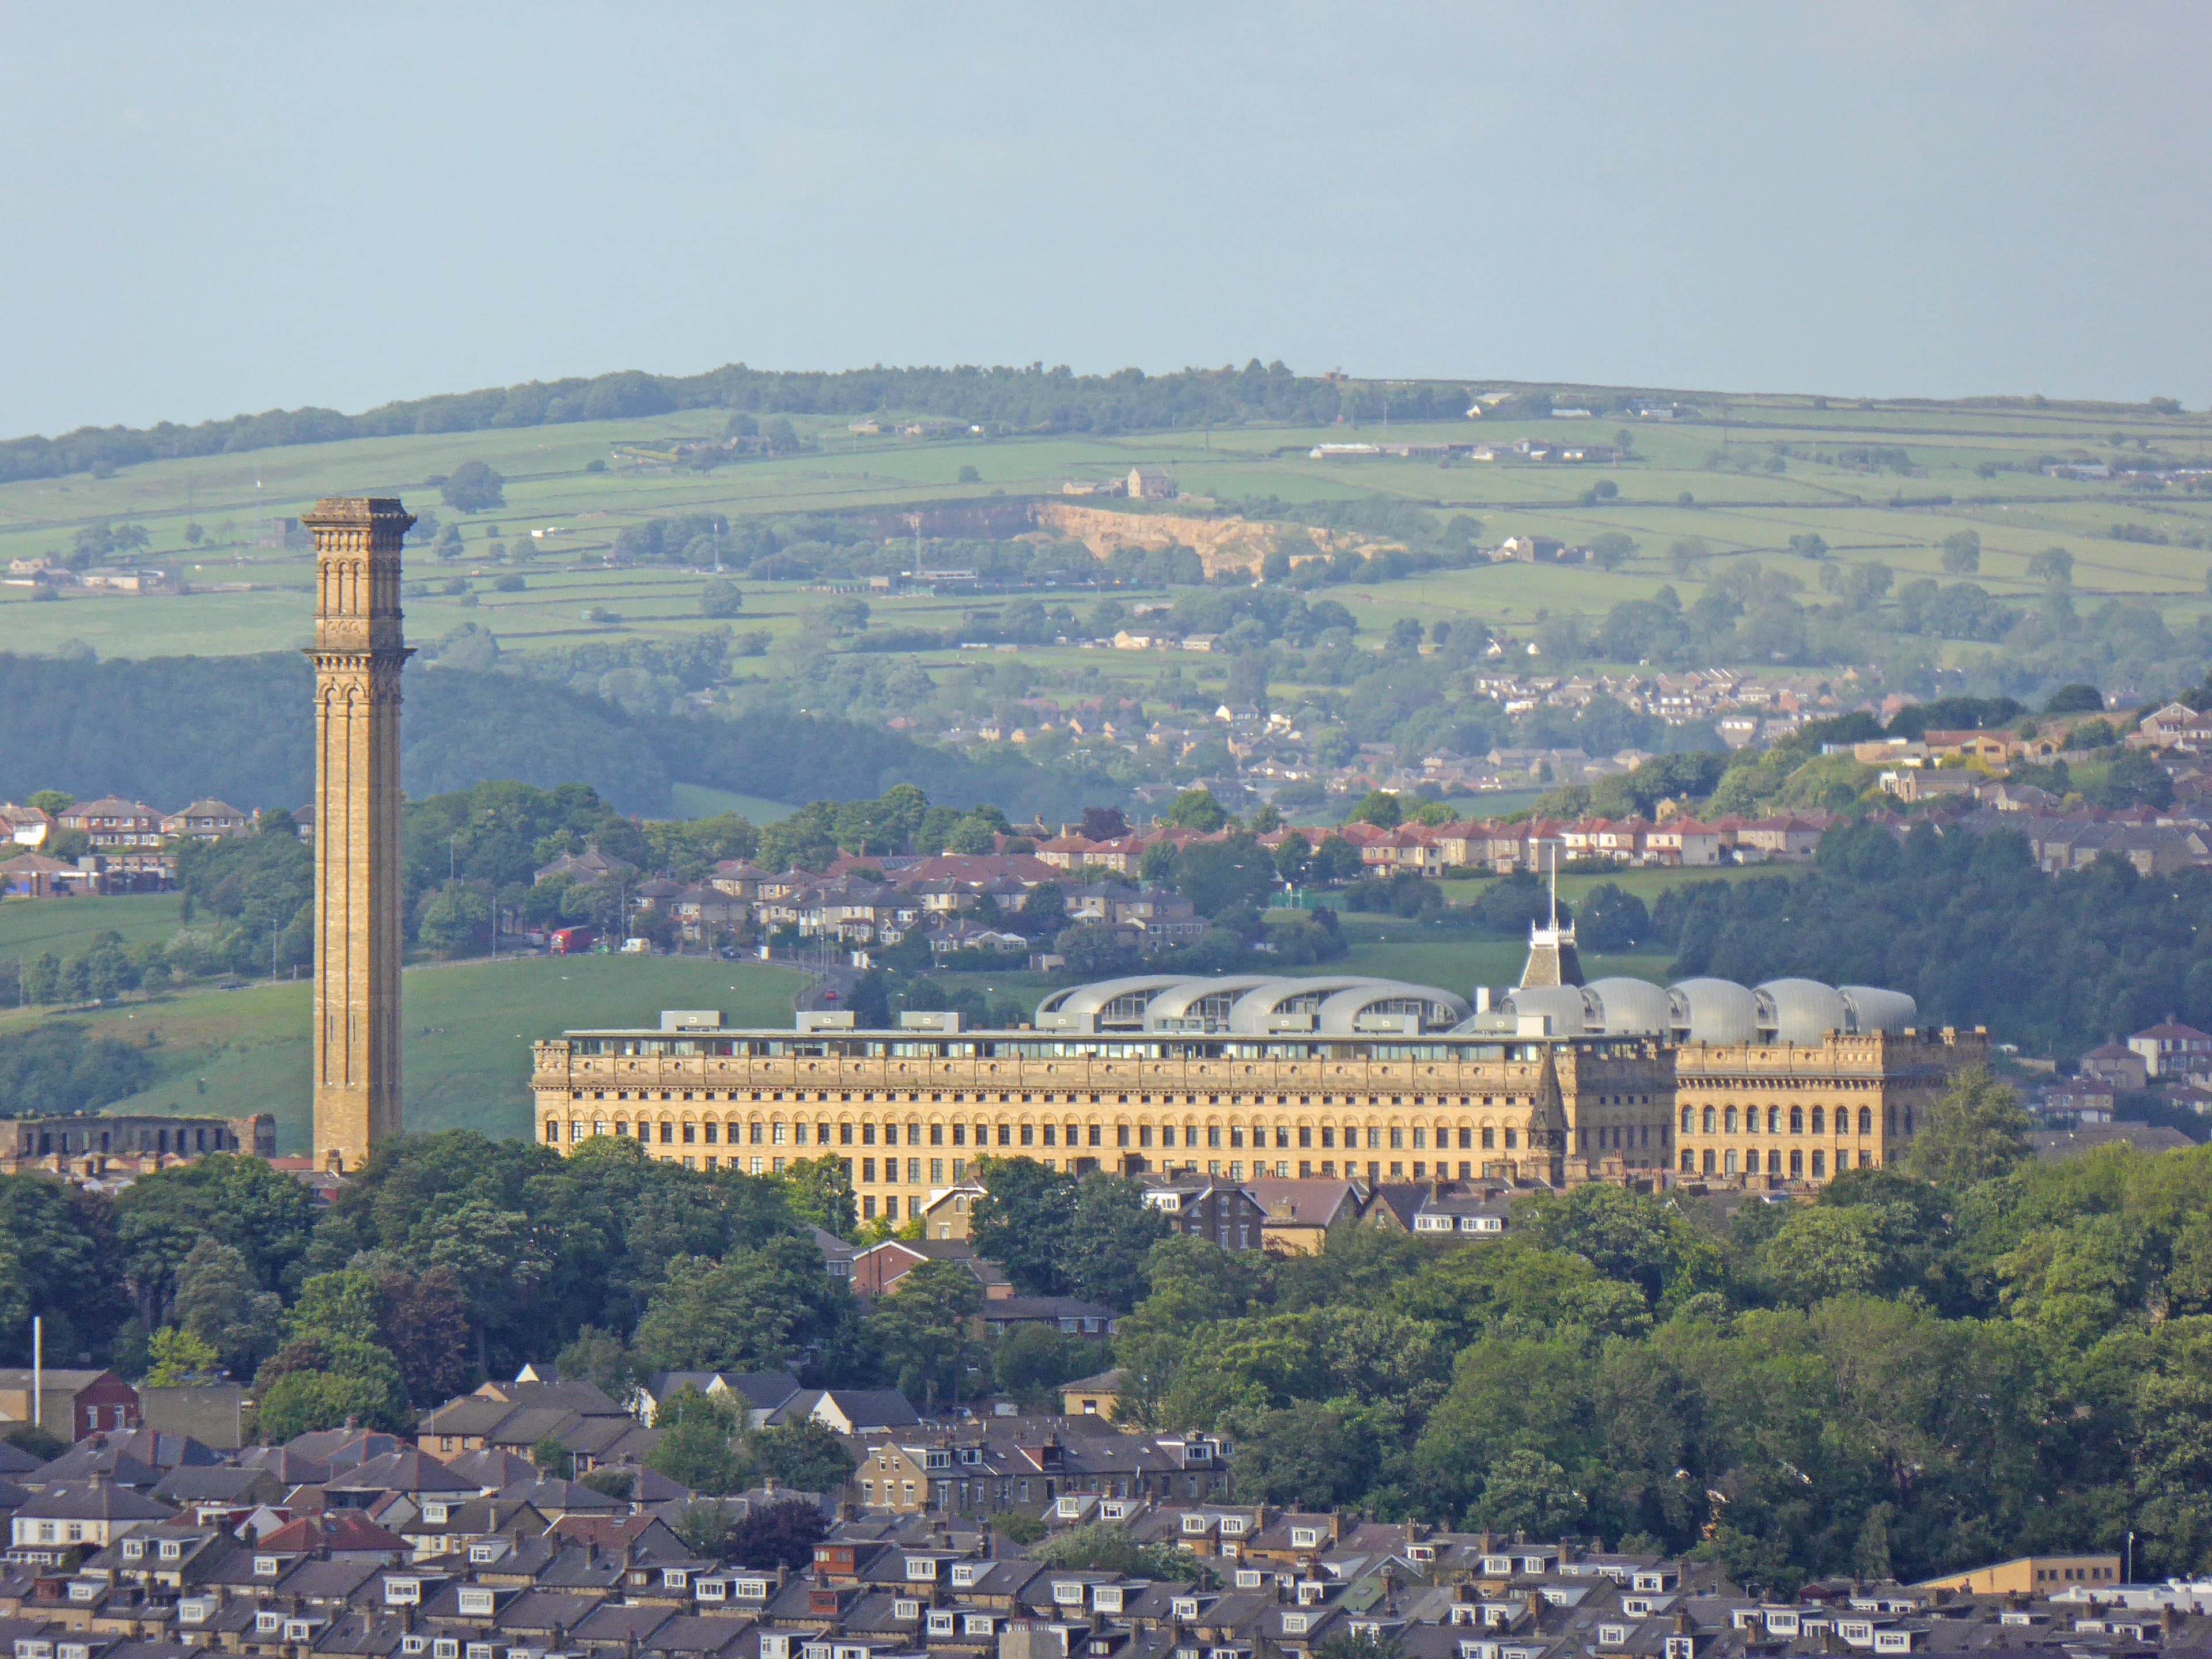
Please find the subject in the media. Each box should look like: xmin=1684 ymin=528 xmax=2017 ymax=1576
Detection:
xmin=1106 ymin=1077 xmax=2212 ymax=1595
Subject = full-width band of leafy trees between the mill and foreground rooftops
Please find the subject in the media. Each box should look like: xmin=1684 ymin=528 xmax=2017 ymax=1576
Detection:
xmin=0 ymin=1097 xmax=2212 ymax=1590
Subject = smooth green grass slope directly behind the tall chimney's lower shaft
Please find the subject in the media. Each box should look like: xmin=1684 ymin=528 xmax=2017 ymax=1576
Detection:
xmin=0 ymin=956 xmax=801 ymax=1153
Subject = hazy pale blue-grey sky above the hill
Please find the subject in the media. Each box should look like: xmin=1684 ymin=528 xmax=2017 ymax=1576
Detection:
xmin=0 ymin=0 xmax=2212 ymax=435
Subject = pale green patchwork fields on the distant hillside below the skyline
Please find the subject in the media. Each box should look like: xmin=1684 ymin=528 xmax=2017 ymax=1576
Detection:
xmin=0 ymin=398 xmax=2212 ymax=703
